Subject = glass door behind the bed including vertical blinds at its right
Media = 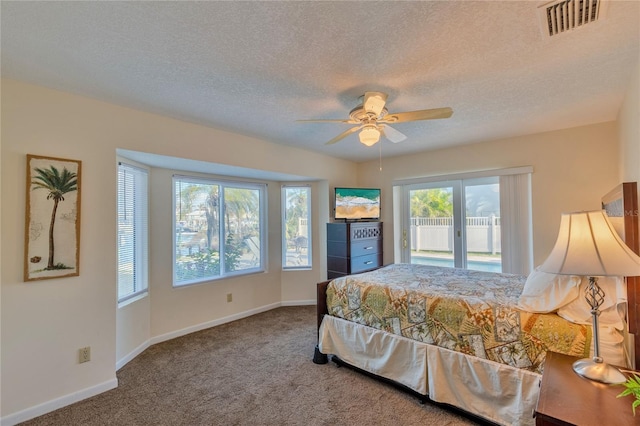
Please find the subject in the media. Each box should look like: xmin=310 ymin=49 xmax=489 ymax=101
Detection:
xmin=395 ymin=167 xmax=533 ymax=274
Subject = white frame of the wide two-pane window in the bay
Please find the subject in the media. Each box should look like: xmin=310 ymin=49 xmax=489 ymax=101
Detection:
xmin=171 ymin=174 xmax=268 ymax=288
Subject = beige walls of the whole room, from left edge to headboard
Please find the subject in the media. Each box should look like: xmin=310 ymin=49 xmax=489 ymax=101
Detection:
xmin=0 ymin=63 xmax=640 ymax=424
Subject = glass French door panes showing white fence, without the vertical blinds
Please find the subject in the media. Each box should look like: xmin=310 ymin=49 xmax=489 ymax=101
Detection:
xmin=402 ymin=177 xmax=502 ymax=272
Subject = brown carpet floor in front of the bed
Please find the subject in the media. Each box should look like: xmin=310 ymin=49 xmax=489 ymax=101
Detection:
xmin=22 ymin=306 xmax=478 ymax=426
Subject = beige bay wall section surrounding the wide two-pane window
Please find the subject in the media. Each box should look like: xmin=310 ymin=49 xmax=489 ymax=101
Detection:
xmin=149 ymin=169 xmax=282 ymax=337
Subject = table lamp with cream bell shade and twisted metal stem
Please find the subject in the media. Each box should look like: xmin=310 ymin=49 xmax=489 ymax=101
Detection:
xmin=539 ymin=210 xmax=640 ymax=383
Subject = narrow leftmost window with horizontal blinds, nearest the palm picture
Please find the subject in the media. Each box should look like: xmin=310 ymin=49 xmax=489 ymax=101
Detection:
xmin=118 ymin=162 xmax=149 ymax=302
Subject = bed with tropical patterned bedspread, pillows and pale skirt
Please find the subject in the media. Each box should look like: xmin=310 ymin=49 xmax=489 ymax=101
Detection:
xmin=314 ymin=183 xmax=638 ymax=425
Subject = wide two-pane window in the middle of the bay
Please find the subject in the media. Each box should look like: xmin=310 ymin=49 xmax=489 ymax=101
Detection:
xmin=173 ymin=176 xmax=266 ymax=286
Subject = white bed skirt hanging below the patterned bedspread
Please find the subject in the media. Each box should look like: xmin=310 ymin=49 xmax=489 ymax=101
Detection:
xmin=319 ymin=315 xmax=541 ymax=425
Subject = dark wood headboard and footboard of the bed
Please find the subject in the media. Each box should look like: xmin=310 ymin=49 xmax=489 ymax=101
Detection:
xmin=313 ymin=182 xmax=640 ymax=369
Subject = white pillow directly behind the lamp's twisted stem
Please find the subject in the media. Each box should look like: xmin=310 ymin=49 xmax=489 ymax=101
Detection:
xmin=558 ymin=277 xmax=627 ymax=330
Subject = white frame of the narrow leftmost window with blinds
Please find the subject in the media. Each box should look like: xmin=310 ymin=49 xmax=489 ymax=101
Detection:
xmin=116 ymin=159 xmax=149 ymax=306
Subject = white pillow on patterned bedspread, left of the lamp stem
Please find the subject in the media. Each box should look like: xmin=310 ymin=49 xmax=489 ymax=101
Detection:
xmin=518 ymin=268 xmax=581 ymax=313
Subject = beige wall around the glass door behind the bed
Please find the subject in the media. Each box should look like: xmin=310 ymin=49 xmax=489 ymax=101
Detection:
xmin=358 ymin=122 xmax=618 ymax=266
